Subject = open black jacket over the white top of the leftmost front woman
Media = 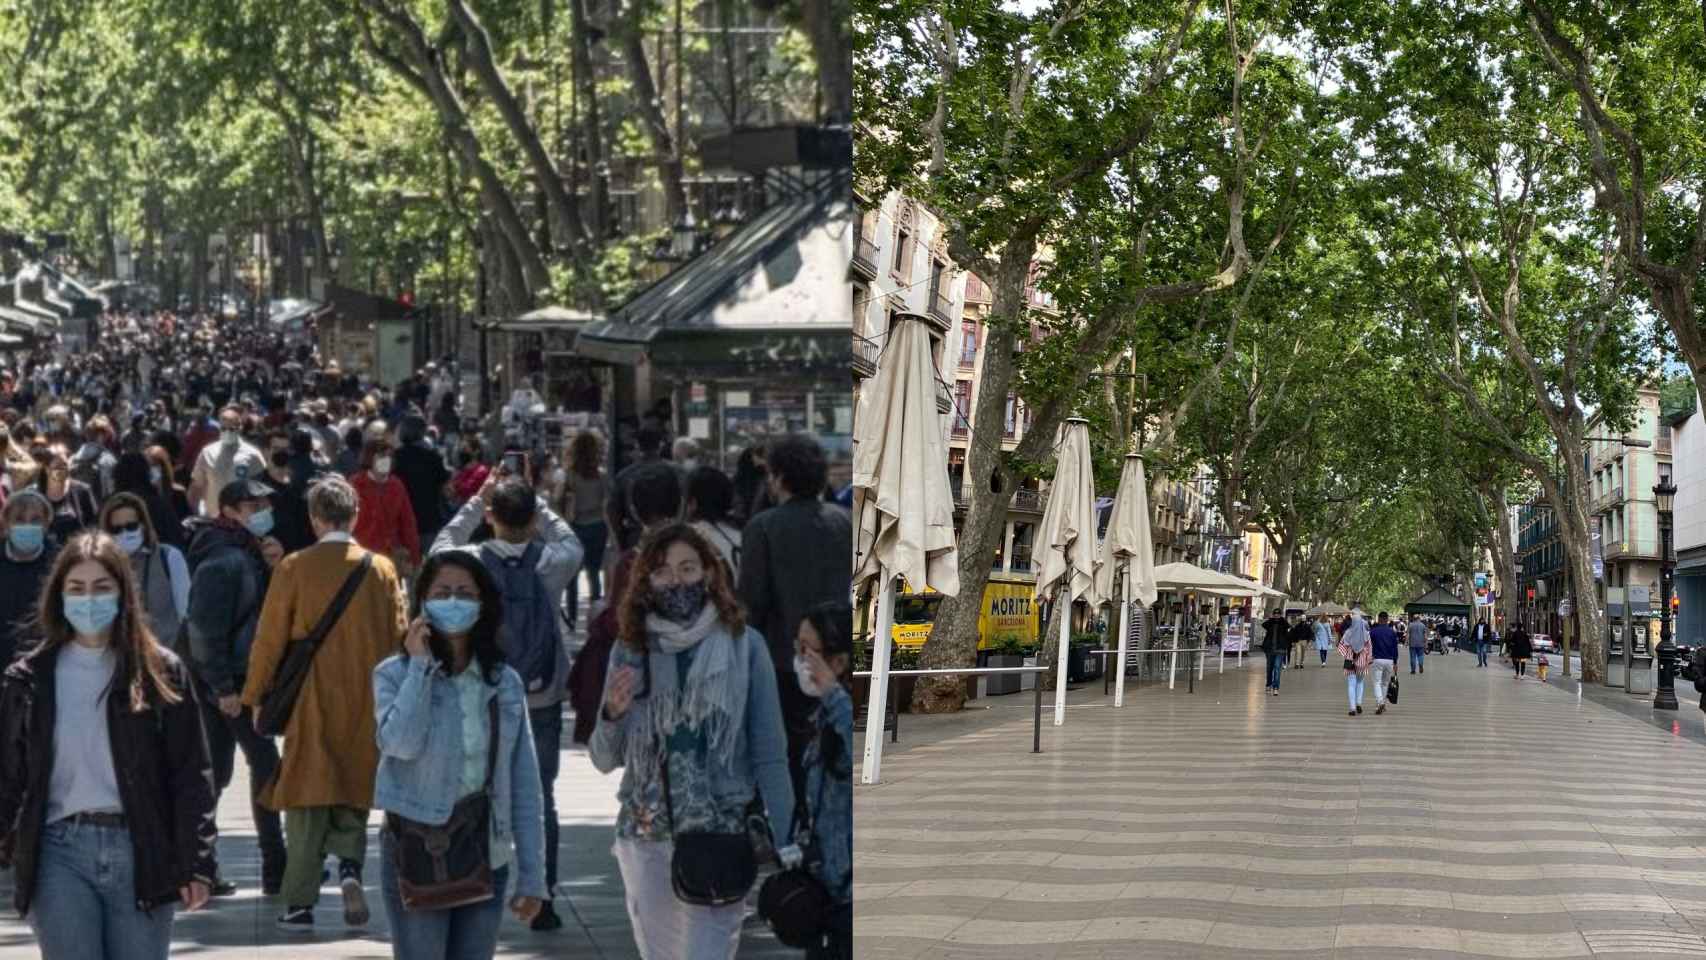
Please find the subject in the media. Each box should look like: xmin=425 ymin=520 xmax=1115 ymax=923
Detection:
xmin=0 ymin=637 xmax=217 ymax=916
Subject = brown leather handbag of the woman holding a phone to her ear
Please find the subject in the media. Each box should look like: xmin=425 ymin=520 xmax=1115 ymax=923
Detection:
xmin=386 ymin=696 xmax=498 ymax=911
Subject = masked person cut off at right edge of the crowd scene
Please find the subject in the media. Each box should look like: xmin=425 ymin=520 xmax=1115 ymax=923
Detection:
xmin=793 ymin=600 xmax=853 ymax=960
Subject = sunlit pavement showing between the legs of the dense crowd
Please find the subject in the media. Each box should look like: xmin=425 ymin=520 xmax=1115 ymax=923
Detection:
xmin=0 ymin=729 xmax=800 ymax=960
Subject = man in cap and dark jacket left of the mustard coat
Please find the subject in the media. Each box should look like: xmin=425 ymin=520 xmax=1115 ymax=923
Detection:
xmin=179 ymin=479 xmax=285 ymax=897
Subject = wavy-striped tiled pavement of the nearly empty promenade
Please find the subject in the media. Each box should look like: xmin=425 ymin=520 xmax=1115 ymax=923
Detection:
xmin=855 ymin=655 xmax=1706 ymax=960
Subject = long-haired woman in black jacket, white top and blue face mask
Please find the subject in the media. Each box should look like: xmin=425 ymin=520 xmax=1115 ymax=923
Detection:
xmin=0 ymin=532 xmax=215 ymax=960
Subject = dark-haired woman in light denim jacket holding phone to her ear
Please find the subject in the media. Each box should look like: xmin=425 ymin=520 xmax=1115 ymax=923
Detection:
xmin=374 ymin=551 xmax=548 ymax=960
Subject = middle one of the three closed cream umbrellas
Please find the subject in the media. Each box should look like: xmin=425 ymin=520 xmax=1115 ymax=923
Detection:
xmin=1036 ymin=418 xmax=1099 ymax=726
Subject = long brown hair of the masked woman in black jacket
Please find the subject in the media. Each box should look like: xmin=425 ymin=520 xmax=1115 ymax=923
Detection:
xmin=36 ymin=530 xmax=184 ymax=713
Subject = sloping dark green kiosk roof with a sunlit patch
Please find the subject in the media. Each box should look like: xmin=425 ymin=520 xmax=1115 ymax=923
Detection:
xmin=577 ymin=179 xmax=853 ymax=372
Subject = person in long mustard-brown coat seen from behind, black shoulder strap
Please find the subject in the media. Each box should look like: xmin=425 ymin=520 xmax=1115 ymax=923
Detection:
xmin=242 ymin=477 xmax=404 ymax=933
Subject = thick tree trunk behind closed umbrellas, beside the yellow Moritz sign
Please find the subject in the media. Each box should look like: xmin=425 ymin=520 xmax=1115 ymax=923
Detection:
xmin=913 ymin=234 xmax=1030 ymax=713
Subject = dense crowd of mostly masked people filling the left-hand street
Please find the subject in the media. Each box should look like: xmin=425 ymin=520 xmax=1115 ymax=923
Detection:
xmin=0 ymin=314 xmax=853 ymax=960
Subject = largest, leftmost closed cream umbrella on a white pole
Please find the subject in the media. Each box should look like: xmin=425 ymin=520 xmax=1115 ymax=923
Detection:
xmin=853 ymin=314 xmax=959 ymax=783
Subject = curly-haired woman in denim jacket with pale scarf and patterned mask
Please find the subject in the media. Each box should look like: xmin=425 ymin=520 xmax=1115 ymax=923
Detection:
xmin=589 ymin=523 xmax=800 ymax=960
